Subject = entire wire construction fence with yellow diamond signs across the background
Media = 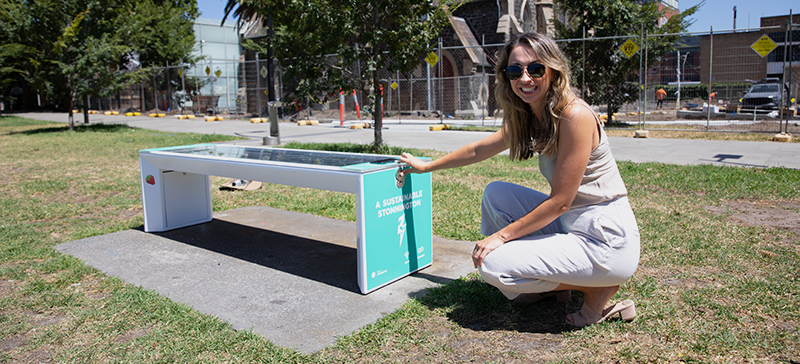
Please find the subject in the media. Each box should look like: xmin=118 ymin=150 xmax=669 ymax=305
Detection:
xmin=91 ymin=20 xmax=800 ymax=133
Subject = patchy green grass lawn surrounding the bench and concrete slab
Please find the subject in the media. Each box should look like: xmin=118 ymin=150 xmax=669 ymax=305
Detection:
xmin=0 ymin=116 xmax=800 ymax=363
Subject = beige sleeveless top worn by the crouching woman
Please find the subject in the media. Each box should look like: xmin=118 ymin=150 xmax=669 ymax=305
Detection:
xmin=539 ymin=100 xmax=628 ymax=208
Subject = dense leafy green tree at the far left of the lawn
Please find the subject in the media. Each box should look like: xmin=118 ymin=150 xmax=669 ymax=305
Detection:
xmin=0 ymin=0 xmax=199 ymax=126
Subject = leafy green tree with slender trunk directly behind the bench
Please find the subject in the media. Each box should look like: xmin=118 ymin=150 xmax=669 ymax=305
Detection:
xmin=226 ymin=0 xmax=458 ymax=151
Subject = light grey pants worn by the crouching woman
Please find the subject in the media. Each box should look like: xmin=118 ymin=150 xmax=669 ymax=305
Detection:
xmin=478 ymin=182 xmax=639 ymax=299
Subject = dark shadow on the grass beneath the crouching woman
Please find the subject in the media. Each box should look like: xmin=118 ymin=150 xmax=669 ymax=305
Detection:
xmin=419 ymin=275 xmax=575 ymax=334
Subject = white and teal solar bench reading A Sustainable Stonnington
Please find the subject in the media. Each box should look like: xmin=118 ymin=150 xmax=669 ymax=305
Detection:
xmin=139 ymin=144 xmax=433 ymax=294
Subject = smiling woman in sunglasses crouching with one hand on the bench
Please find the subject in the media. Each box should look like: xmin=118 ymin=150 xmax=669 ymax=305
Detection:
xmin=399 ymin=33 xmax=640 ymax=327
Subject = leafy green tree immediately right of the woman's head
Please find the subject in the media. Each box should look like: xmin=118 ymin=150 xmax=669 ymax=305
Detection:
xmin=555 ymin=0 xmax=703 ymax=122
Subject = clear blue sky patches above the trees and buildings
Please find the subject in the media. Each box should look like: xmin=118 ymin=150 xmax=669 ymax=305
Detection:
xmin=197 ymin=0 xmax=800 ymax=33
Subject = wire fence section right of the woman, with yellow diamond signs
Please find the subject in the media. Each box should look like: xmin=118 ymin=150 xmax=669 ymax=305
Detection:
xmin=559 ymin=24 xmax=800 ymax=133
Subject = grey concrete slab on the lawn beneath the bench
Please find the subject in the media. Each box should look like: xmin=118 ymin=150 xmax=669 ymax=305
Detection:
xmin=56 ymin=206 xmax=474 ymax=353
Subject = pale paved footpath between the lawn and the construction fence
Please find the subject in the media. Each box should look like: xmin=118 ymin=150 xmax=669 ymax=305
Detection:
xmin=20 ymin=113 xmax=800 ymax=169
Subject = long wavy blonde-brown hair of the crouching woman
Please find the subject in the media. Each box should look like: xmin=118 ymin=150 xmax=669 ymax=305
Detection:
xmin=494 ymin=33 xmax=577 ymax=160
